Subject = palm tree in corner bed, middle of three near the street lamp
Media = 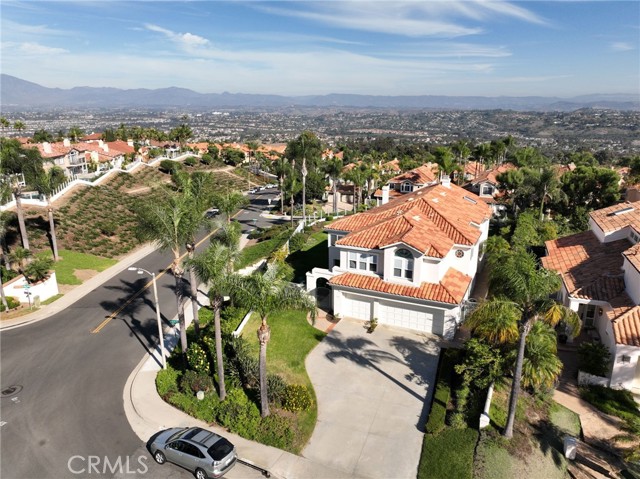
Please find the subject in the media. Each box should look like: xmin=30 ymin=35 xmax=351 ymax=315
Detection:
xmin=188 ymin=240 xmax=240 ymax=401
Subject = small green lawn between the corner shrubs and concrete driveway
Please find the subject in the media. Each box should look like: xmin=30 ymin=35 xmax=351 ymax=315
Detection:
xmin=242 ymin=311 xmax=326 ymax=447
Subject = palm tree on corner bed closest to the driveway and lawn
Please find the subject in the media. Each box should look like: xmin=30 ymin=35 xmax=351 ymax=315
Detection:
xmin=236 ymin=263 xmax=316 ymax=417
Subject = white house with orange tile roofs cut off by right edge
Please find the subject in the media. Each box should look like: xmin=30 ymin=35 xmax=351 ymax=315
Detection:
xmin=542 ymin=201 xmax=640 ymax=394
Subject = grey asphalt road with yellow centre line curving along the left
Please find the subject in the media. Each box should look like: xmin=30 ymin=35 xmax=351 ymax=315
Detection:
xmin=0 ymin=190 xmax=275 ymax=479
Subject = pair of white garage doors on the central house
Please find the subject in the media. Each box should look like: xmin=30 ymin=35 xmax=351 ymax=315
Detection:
xmin=343 ymin=293 xmax=433 ymax=333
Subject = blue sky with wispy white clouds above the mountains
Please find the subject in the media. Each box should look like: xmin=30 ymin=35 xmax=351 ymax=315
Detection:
xmin=0 ymin=0 xmax=640 ymax=98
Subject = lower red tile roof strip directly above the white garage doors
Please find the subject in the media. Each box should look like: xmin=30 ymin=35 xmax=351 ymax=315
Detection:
xmin=329 ymin=268 xmax=472 ymax=304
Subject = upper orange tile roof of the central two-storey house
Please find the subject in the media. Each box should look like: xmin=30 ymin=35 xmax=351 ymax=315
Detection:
xmin=328 ymin=184 xmax=491 ymax=258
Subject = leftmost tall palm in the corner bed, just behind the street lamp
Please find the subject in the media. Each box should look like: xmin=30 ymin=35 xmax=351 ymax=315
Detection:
xmin=136 ymin=189 xmax=206 ymax=354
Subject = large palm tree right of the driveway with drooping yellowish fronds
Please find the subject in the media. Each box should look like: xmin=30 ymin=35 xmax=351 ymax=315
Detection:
xmin=467 ymin=248 xmax=581 ymax=438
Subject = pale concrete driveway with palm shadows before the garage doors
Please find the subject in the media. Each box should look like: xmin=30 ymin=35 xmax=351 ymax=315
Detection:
xmin=302 ymin=319 xmax=440 ymax=479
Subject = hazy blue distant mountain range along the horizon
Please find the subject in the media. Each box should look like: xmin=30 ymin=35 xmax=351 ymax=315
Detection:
xmin=0 ymin=74 xmax=640 ymax=111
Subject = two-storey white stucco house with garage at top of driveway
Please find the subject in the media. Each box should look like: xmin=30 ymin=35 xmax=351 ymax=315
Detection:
xmin=307 ymin=178 xmax=491 ymax=338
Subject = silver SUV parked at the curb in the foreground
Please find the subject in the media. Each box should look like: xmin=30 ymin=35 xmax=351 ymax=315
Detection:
xmin=150 ymin=427 xmax=238 ymax=479
